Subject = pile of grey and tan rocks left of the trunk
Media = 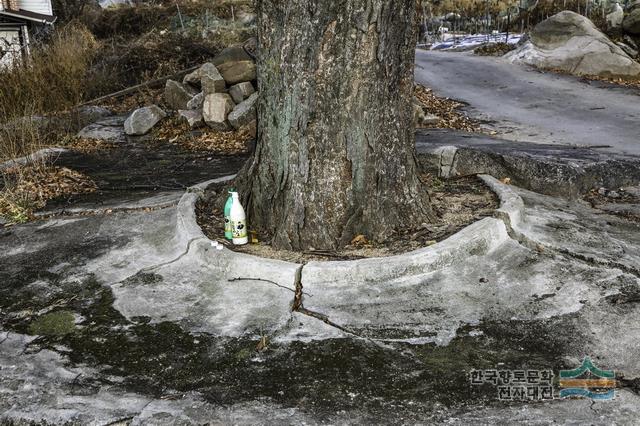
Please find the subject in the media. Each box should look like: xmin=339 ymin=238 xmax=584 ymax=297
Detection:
xmin=125 ymin=41 xmax=258 ymax=136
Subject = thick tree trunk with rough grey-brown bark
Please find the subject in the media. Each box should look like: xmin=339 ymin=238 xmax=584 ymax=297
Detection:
xmin=238 ymin=0 xmax=433 ymax=249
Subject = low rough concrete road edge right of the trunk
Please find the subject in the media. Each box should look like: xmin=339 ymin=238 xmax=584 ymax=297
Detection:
xmin=416 ymin=129 xmax=640 ymax=199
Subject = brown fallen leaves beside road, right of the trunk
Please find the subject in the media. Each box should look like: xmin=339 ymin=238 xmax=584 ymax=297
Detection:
xmin=414 ymin=84 xmax=482 ymax=132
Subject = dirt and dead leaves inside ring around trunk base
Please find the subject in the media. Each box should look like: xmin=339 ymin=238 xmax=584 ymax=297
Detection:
xmin=196 ymin=175 xmax=498 ymax=262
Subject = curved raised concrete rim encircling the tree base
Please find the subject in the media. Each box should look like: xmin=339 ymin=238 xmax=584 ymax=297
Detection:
xmin=177 ymin=176 xmax=523 ymax=287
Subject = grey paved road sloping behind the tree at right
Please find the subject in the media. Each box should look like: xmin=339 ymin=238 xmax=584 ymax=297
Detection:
xmin=416 ymin=50 xmax=640 ymax=156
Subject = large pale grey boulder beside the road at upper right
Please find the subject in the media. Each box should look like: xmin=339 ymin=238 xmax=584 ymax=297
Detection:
xmin=505 ymin=11 xmax=640 ymax=77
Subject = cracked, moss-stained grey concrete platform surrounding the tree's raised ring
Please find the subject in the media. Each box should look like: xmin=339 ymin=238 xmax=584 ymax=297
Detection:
xmin=0 ymin=176 xmax=640 ymax=424
